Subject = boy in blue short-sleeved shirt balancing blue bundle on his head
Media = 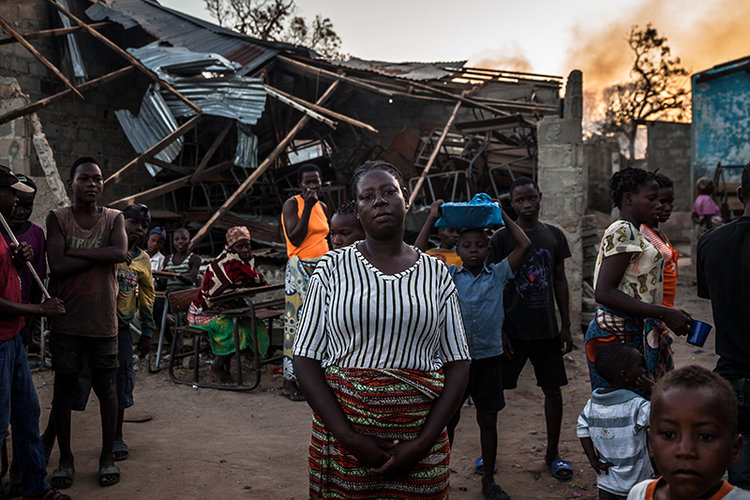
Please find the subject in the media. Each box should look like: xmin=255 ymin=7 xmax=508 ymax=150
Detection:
xmin=448 ymin=214 xmax=531 ymax=500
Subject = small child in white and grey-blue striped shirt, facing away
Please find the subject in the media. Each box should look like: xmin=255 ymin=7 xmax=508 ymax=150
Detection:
xmin=577 ymin=342 xmax=653 ymax=500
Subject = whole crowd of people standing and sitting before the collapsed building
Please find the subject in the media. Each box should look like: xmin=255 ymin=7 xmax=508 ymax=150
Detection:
xmin=0 ymin=154 xmax=750 ymax=500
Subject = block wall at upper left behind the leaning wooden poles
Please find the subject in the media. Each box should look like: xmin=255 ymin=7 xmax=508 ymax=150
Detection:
xmin=0 ymin=0 xmax=152 ymax=207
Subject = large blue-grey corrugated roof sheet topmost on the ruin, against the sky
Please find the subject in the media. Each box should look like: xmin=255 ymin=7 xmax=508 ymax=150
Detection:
xmin=86 ymin=0 xmax=280 ymax=74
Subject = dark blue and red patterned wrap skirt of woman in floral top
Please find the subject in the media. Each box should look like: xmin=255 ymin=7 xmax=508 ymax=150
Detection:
xmin=585 ymin=306 xmax=674 ymax=397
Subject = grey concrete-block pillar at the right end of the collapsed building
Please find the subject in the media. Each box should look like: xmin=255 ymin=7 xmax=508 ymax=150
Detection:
xmin=537 ymin=70 xmax=587 ymax=332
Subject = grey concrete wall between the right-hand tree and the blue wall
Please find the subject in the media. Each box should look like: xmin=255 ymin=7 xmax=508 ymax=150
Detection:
xmin=646 ymin=121 xmax=693 ymax=251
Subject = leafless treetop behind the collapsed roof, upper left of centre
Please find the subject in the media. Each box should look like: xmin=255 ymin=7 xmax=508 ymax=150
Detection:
xmin=203 ymin=0 xmax=343 ymax=59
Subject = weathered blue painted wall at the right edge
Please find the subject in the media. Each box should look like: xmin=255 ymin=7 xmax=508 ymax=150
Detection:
xmin=690 ymin=66 xmax=750 ymax=185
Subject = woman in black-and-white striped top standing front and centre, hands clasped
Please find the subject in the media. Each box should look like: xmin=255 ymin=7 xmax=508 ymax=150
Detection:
xmin=294 ymin=162 xmax=470 ymax=498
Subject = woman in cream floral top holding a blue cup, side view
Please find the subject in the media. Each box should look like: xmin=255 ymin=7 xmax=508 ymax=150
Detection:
xmin=586 ymin=168 xmax=690 ymax=394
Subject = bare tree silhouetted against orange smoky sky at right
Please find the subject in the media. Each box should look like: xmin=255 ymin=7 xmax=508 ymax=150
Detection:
xmin=602 ymin=23 xmax=690 ymax=159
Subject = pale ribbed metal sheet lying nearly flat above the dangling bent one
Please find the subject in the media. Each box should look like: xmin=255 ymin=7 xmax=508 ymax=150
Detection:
xmin=162 ymin=75 xmax=266 ymax=125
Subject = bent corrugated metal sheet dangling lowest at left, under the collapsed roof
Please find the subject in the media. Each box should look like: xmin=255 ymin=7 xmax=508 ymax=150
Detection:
xmin=115 ymin=85 xmax=184 ymax=175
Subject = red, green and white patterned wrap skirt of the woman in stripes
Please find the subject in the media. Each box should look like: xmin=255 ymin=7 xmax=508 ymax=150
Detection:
xmin=309 ymin=367 xmax=450 ymax=499
